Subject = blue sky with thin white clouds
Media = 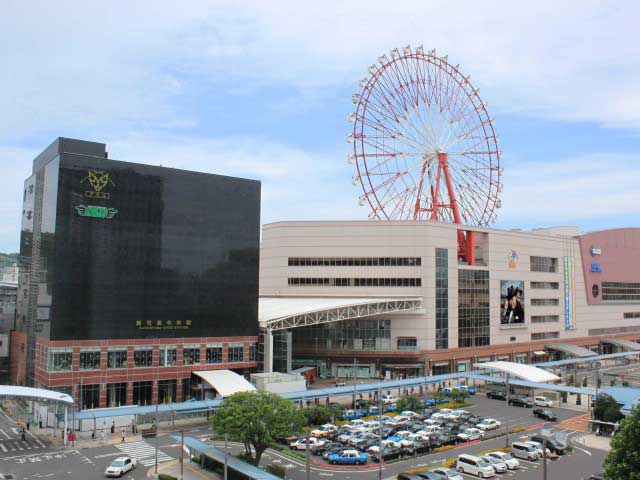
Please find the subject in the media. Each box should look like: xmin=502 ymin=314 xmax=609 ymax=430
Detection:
xmin=0 ymin=0 xmax=640 ymax=251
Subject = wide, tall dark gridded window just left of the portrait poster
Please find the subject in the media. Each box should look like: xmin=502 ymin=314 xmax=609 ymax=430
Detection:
xmin=458 ymin=269 xmax=491 ymax=348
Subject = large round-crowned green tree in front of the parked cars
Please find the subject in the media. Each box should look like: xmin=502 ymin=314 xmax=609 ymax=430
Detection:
xmin=211 ymin=391 xmax=305 ymax=465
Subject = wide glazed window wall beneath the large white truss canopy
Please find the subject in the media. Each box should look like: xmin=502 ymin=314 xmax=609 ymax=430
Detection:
xmin=294 ymin=318 xmax=391 ymax=352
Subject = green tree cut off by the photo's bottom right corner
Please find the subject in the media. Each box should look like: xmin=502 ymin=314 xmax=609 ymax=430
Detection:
xmin=598 ymin=400 xmax=640 ymax=480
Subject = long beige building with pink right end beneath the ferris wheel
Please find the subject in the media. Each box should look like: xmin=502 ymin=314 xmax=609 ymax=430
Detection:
xmin=260 ymin=221 xmax=640 ymax=378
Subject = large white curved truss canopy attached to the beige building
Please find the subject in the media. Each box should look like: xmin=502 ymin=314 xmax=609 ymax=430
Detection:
xmin=258 ymin=297 xmax=422 ymax=331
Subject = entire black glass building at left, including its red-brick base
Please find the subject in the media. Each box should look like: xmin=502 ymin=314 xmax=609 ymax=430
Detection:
xmin=10 ymin=138 xmax=260 ymax=408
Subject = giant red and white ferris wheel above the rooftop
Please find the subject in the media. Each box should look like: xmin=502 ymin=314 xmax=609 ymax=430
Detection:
xmin=347 ymin=46 xmax=502 ymax=232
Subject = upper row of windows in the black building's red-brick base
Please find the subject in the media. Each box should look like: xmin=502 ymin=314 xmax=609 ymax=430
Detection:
xmin=48 ymin=345 xmax=257 ymax=372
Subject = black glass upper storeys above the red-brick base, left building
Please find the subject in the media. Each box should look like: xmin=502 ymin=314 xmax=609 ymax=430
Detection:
xmin=17 ymin=138 xmax=260 ymax=384
